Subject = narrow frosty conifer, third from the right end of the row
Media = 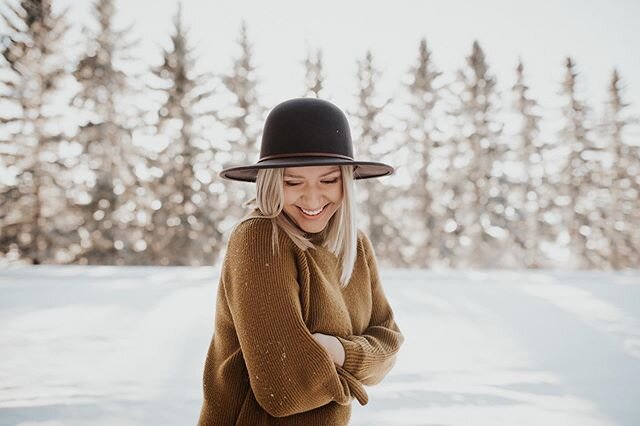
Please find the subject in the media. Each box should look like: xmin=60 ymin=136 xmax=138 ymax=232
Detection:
xmin=508 ymin=61 xmax=555 ymax=268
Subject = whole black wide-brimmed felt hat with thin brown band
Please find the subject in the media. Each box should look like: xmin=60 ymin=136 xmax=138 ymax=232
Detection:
xmin=220 ymin=98 xmax=394 ymax=182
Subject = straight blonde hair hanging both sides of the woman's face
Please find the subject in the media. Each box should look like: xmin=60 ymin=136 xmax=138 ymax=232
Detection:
xmin=239 ymin=165 xmax=358 ymax=287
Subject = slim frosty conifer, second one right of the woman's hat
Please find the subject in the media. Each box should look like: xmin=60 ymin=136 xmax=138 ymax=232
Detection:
xmin=402 ymin=39 xmax=449 ymax=268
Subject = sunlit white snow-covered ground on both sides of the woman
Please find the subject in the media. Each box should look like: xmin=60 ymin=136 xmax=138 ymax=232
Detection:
xmin=0 ymin=266 xmax=640 ymax=426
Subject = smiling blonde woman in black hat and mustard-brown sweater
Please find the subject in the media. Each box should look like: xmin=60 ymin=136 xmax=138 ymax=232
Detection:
xmin=199 ymin=98 xmax=403 ymax=426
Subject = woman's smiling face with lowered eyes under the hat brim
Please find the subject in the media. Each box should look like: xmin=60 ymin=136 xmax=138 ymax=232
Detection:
xmin=284 ymin=166 xmax=342 ymax=233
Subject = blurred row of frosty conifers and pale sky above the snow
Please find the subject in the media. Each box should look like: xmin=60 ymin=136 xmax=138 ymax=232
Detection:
xmin=0 ymin=0 xmax=640 ymax=269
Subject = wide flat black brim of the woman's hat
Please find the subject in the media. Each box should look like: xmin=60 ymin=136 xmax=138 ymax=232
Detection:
xmin=220 ymin=157 xmax=394 ymax=182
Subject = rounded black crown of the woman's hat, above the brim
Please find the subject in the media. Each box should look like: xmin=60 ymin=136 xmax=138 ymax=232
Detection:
xmin=260 ymin=98 xmax=353 ymax=161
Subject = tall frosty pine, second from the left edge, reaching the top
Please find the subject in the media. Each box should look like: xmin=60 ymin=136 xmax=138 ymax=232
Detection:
xmin=72 ymin=0 xmax=148 ymax=264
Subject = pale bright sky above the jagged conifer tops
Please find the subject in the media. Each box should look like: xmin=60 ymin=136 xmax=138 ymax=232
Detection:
xmin=54 ymin=0 xmax=640 ymax=116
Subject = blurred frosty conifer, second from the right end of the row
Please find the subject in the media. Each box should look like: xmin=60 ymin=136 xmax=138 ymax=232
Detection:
xmin=556 ymin=58 xmax=608 ymax=268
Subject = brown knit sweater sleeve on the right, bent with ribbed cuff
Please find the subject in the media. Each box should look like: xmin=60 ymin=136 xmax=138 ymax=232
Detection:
xmin=337 ymin=233 xmax=404 ymax=385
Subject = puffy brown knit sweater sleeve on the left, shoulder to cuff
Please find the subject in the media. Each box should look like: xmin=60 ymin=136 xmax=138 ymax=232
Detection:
xmin=223 ymin=219 xmax=367 ymax=417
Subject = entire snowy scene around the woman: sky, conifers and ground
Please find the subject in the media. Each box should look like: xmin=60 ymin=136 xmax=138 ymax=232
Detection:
xmin=0 ymin=0 xmax=640 ymax=426
